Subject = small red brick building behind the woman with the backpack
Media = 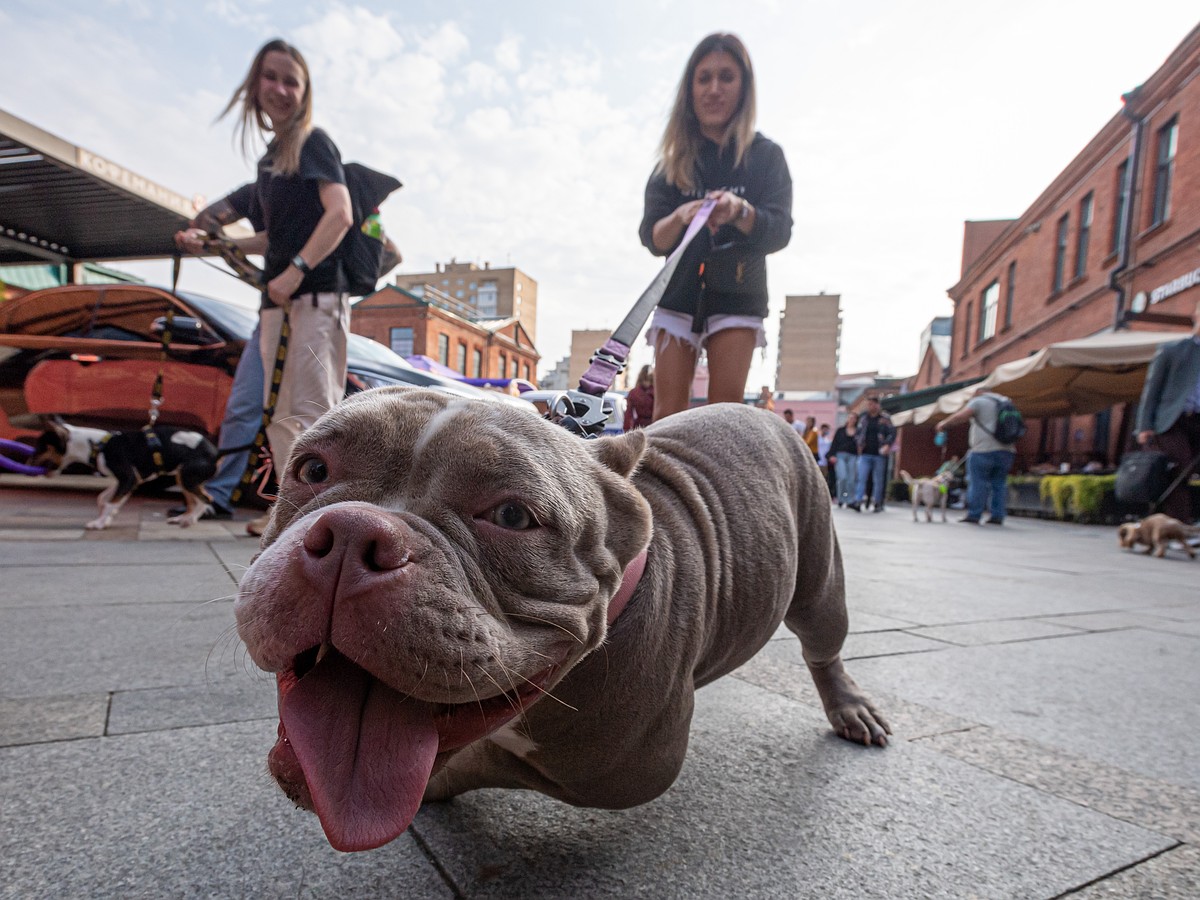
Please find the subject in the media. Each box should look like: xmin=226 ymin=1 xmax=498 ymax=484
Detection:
xmin=350 ymin=284 xmax=541 ymax=383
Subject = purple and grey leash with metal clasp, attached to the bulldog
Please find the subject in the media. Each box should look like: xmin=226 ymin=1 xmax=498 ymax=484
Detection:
xmin=546 ymin=199 xmax=716 ymax=438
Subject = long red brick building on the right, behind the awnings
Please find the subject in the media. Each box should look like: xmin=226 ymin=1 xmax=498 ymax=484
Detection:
xmin=902 ymin=26 xmax=1200 ymax=474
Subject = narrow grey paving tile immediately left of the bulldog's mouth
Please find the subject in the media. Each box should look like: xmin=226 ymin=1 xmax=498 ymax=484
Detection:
xmin=108 ymin=681 xmax=277 ymax=734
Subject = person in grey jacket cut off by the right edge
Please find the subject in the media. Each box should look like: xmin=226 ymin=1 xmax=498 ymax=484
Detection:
xmin=1135 ymin=302 xmax=1200 ymax=524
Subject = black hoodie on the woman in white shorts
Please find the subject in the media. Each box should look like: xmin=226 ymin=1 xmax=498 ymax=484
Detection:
xmin=638 ymin=134 xmax=792 ymax=331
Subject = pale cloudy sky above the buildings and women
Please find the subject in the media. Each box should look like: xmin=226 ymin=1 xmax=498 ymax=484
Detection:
xmin=0 ymin=0 xmax=1200 ymax=388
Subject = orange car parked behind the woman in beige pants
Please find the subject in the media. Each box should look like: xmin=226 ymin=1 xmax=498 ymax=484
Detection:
xmin=0 ymin=284 xmax=528 ymax=440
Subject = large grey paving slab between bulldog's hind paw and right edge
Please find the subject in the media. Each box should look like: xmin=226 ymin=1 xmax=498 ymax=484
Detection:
xmin=853 ymin=630 xmax=1200 ymax=787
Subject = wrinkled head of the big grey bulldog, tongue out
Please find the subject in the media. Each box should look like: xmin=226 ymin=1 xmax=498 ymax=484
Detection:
xmin=235 ymin=388 xmax=649 ymax=850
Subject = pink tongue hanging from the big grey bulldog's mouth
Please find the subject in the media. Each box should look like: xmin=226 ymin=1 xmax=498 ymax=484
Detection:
xmin=280 ymin=652 xmax=438 ymax=851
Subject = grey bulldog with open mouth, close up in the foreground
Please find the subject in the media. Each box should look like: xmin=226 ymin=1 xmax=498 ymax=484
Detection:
xmin=235 ymin=388 xmax=890 ymax=851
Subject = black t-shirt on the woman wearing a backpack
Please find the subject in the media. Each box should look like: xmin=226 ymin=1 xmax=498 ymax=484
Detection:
xmin=252 ymin=128 xmax=347 ymax=306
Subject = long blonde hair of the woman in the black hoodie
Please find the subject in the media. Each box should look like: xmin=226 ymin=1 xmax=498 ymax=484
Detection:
xmin=655 ymin=32 xmax=756 ymax=192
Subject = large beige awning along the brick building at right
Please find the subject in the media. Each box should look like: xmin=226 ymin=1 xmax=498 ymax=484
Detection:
xmin=892 ymin=331 xmax=1188 ymax=426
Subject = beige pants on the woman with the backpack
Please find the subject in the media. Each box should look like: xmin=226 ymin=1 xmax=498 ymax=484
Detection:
xmin=259 ymin=293 xmax=350 ymax=478
